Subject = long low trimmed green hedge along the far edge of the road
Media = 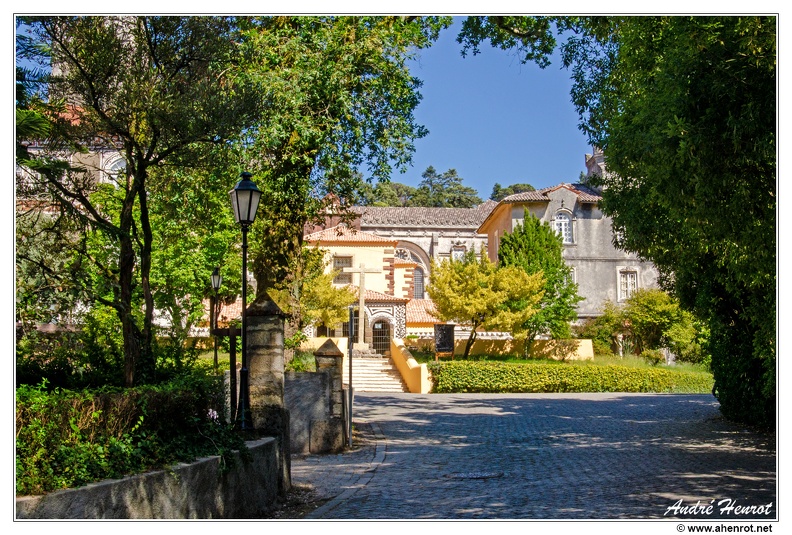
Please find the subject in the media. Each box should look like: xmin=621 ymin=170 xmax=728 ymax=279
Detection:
xmin=429 ymin=361 xmax=712 ymax=393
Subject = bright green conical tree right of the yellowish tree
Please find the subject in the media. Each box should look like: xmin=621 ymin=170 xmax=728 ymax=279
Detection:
xmin=498 ymin=215 xmax=582 ymax=352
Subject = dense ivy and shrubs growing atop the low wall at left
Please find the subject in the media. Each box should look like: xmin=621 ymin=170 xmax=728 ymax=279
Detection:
xmin=16 ymin=373 xmax=244 ymax=495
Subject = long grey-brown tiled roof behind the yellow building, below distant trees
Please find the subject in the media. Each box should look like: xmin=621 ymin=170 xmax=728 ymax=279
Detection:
xmin=353 ymin=200 xmax=498 ymax=228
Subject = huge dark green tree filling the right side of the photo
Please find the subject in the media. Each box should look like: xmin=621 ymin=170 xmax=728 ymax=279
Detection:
xmin=460 ymin=16 xmax=777 ymax=425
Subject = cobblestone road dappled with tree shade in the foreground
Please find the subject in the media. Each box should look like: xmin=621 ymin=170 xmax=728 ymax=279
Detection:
xmin=292 ymin=394 xmax=777 ymax=520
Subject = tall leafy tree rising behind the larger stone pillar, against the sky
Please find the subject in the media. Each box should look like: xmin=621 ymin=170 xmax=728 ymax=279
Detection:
xmin=234 ymin=17 xmax=450 ymax=316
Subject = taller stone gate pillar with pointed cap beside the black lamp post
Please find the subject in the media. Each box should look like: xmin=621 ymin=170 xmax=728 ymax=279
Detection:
xmin=246 ymin=293 xmax=291 ymax=492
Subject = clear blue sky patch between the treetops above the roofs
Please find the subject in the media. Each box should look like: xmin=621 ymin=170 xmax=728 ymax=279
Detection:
xmin=391 ymin=18 xmax=591 ymax=199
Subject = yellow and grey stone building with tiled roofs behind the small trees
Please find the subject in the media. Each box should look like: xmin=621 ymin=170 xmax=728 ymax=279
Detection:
xmin=305 ymin=149 xmax=658 ymax=354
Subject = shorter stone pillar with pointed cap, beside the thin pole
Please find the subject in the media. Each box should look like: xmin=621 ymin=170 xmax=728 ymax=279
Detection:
xmin=310 ymin=338 xmax=345 ymax=453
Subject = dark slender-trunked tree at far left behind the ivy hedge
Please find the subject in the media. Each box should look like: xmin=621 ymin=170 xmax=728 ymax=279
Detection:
xmin=18 ymin=17 xmax=259 ymax=385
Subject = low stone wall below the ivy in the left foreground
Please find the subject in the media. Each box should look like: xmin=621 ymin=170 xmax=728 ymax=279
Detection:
xmin=16 ymin=438 xmax=279 ymax=520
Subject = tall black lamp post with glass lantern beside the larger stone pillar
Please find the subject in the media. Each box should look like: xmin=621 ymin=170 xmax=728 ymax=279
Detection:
xmin=229 ymin=172 xmax=261 ymax=432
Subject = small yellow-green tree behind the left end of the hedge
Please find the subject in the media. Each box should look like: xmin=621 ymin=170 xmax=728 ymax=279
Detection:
xmin=427 ymin=251 xmax=544 ymax=357
